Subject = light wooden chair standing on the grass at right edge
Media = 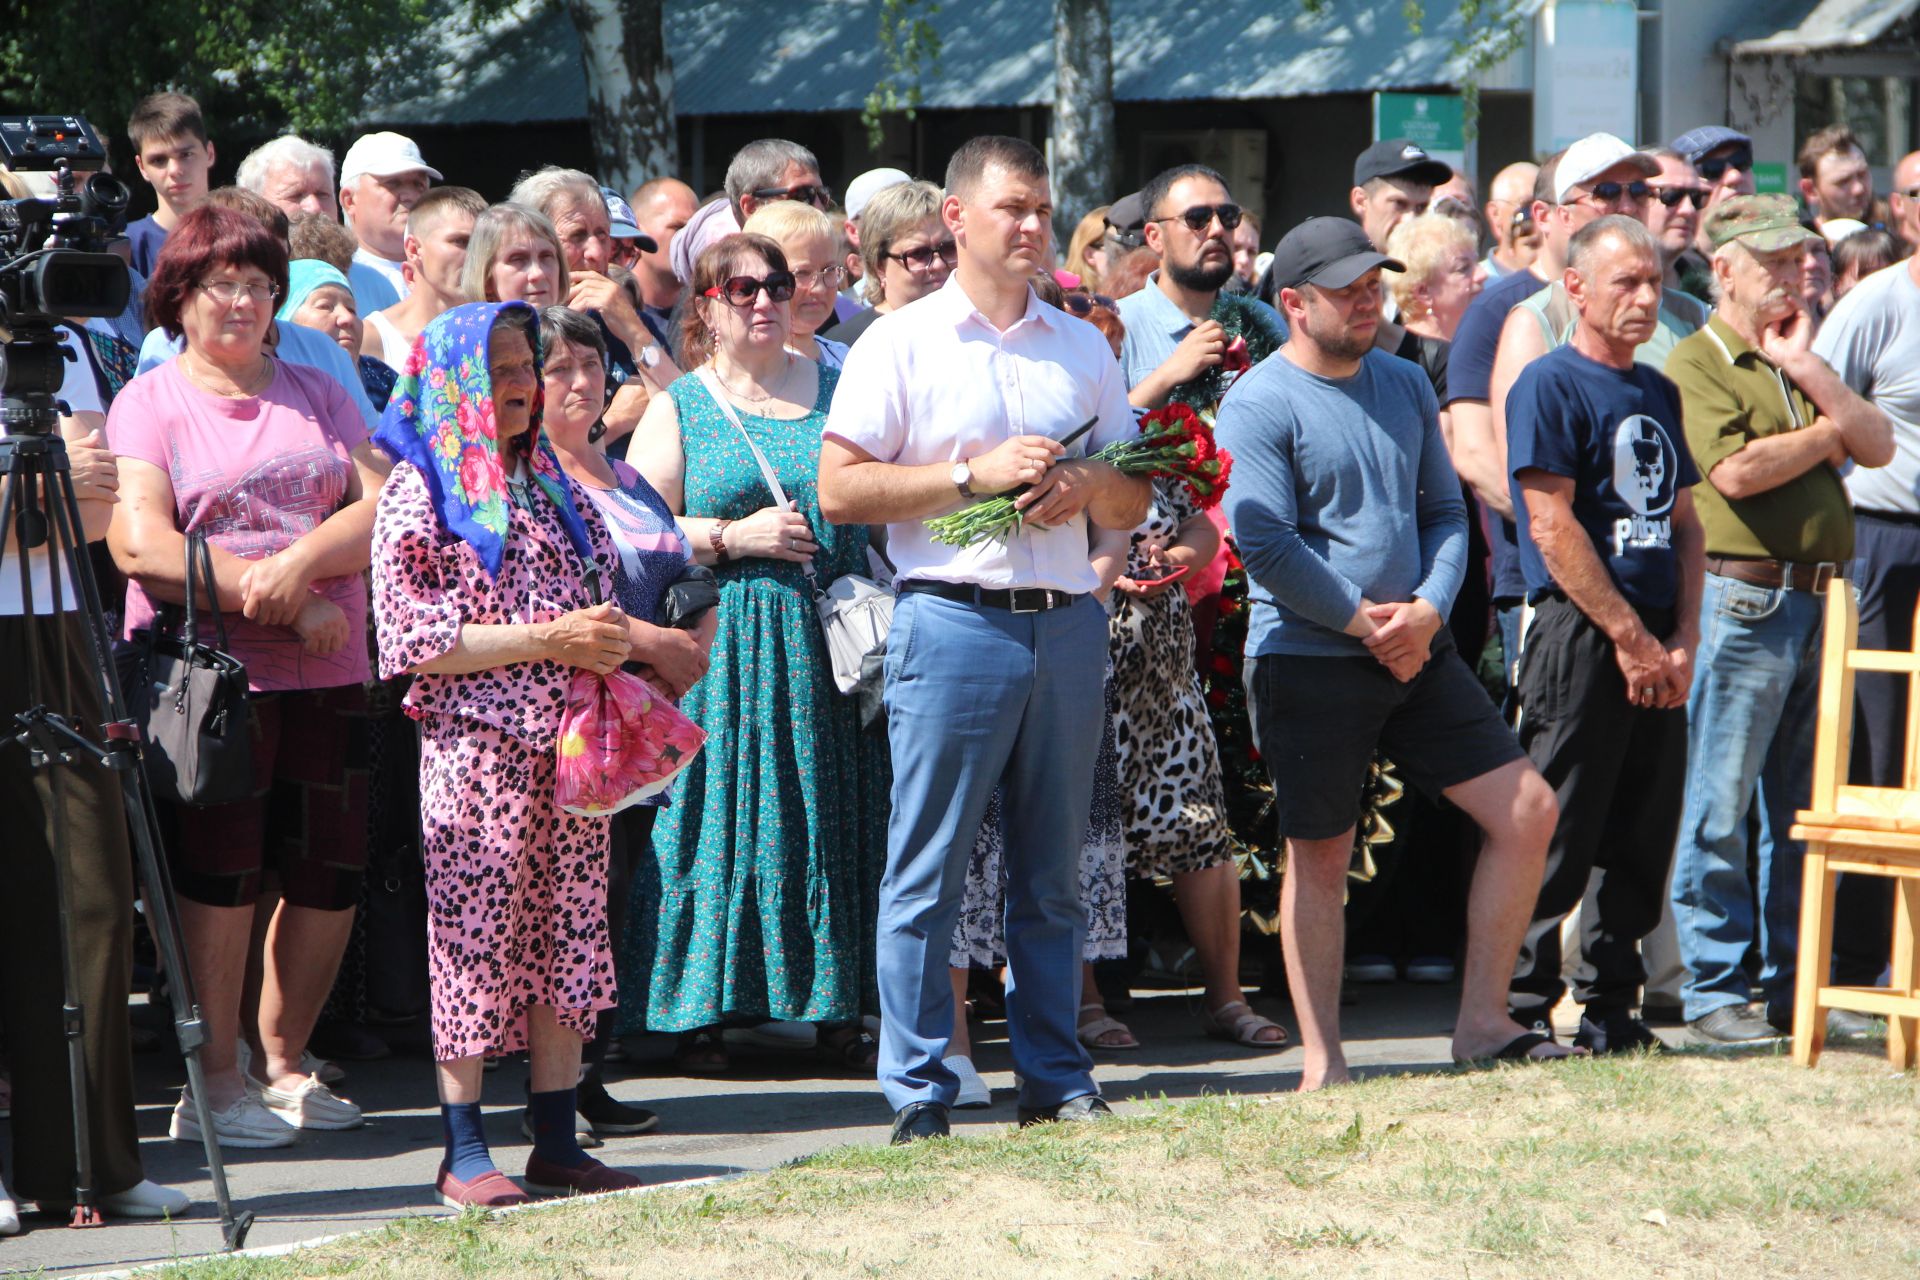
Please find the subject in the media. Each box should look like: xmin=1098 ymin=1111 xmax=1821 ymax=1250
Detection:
xmin=1791 ymin=578 xmax=1920 ymax=1069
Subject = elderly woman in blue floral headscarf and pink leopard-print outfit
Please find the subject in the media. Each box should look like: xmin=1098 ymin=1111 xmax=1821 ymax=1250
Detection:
xmin=372 ymin=301 xmax=639 ymax=1207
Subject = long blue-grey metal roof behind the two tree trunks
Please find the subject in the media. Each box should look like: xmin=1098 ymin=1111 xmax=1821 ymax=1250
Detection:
xmin=367 ymin=0 xmax=1544 ymax=125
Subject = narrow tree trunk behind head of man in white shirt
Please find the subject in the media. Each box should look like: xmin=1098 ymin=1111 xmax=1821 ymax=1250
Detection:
xmin=1052 ymin=0 xmax=1119 ymax=235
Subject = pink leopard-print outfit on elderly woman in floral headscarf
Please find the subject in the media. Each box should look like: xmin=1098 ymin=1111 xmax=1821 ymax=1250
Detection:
xmin=372 ymin=462 xmax=618 ymax=1061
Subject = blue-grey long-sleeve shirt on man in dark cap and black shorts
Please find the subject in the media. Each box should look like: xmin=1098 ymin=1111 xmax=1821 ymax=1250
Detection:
xmin=1215 ymin=349 xmax=1467 ymax=656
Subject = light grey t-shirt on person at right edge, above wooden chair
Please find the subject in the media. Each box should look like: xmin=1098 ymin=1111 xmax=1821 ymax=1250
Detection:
xmin=1812 ymin=259 xmax=1920 ymax=516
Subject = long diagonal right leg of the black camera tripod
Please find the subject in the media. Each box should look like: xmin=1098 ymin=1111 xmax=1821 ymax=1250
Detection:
xmin=50 ymin=470 xmax=253 ymax=1249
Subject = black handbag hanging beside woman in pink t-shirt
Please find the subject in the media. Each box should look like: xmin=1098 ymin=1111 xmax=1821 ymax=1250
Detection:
xmin=129 ymin=533 xmax=253 ymax=806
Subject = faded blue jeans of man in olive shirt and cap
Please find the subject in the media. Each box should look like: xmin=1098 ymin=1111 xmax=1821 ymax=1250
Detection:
xmin=1672 ymin=574 xmax=1826 ymax=1021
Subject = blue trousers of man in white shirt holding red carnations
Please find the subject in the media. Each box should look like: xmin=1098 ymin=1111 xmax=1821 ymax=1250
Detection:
xmin=877 ymin=591 xmax=1106 ymax=1111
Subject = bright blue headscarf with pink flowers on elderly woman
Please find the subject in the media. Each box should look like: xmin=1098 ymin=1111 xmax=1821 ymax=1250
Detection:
xmin=372 ymin=301 xmax=595 ymax=578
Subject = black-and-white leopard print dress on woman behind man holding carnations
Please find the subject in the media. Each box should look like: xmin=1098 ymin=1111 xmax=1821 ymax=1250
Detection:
xmin=1110 ymin=478 xmax=1233 ymax=879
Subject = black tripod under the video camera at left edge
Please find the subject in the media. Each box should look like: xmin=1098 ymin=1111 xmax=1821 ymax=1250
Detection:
xmin=0 ymin=420 xmax=253 ymax=1249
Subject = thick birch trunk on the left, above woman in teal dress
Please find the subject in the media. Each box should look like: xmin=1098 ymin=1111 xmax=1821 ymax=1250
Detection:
xmin=566 ymin=0 xmax=680 ymax=192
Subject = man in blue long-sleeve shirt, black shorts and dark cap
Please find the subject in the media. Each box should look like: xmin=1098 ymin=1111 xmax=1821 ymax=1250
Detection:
xmin=1217 ymin=219 xmax=1565 ymax=1088
